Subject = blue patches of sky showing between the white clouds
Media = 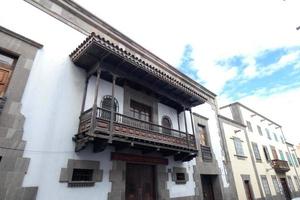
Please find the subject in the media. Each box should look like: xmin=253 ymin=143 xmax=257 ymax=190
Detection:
xmin=178 ymin=44 xmax=300 ymax=101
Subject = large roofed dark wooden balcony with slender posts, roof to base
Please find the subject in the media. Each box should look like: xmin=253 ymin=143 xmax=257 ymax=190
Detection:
xmin=70 ymin=34 xmax=215 ymax=161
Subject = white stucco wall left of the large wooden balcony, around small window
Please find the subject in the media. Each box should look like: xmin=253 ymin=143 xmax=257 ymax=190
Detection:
xmin=0 ymin=0 xmax=111 ymax=200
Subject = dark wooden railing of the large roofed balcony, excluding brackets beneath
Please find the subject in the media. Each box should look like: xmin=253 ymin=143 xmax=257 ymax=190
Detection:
xmin=77 ymin=108 xmax=197 ymax=159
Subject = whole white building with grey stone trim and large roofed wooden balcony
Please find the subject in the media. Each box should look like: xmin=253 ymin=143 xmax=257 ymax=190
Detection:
xmin=0 ymin=0 xmax=233 ymax=200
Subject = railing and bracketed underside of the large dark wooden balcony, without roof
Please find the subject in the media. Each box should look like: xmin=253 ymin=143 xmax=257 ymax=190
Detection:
xmin=74 ymin=108 xmax=198 ymax=161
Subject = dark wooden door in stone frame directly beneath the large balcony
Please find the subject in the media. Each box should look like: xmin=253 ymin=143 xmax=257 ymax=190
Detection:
xmin=125 ymin=163 xmax=156 ymax=200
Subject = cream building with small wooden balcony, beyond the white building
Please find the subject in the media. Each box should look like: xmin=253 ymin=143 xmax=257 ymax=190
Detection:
xmin=219 ymin=102 xmax=300 ymax=200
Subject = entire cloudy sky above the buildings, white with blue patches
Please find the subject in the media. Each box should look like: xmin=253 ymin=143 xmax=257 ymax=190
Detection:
xmin=75 ymin=0 xmax=300 ymax=143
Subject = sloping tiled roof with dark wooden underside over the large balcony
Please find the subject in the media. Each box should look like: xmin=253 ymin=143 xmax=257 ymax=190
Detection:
xmin=70 ymin=33 xmax=215 ymax=108
